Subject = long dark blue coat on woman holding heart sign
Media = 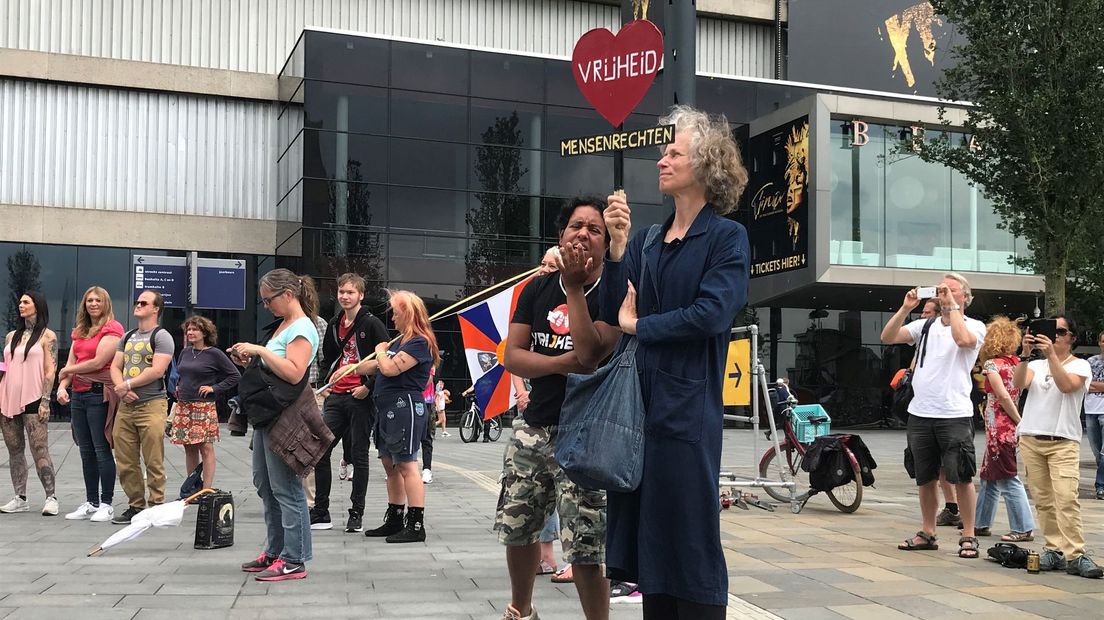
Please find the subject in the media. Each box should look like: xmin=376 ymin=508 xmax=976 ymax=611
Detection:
xmin=599 ymin=205 xmax=751 ymax=605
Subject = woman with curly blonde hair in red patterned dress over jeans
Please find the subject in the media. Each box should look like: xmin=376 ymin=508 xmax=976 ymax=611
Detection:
xmin=974 ymin=317 xmax=1034 ymax=543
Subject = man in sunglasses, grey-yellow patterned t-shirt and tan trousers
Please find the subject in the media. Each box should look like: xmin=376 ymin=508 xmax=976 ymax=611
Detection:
xmin=112 ymin=290 xmax=176 ymax=524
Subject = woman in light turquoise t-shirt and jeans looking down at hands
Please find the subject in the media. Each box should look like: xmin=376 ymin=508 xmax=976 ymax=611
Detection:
xmin=230 ymin=269 xmax=318 ymax=581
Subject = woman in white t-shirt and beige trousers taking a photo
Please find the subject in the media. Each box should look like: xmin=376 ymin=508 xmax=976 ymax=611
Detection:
xmin=1012 ymin=316 xmax=1104 ymax=579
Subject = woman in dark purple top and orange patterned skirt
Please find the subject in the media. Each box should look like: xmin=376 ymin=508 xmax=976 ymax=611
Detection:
xmin=172 ymin=317 xmax=242 ymax=489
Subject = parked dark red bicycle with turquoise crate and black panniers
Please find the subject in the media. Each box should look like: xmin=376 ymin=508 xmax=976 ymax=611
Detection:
xmin=758 ymin=389 xmax=862 ymax=514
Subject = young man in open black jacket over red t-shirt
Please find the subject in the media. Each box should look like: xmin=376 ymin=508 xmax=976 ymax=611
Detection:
xmin=310 ymin=274 xmax=388 ymax=533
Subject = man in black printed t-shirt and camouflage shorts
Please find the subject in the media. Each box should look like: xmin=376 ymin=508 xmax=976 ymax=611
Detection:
xmin=495 ymin=197 xmax=609 ymax=620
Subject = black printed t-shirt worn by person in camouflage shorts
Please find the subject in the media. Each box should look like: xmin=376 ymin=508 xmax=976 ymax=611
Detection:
xmin=510 ymin=274 xmax=598 ymax=427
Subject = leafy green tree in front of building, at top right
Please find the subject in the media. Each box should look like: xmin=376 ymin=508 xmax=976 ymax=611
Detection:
xmin=915 ymin=0 xmax=1104 ymax=314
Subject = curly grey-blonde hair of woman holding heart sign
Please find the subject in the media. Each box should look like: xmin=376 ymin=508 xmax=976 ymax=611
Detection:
xmin=659 ymin=106 xmax=747 ymax=215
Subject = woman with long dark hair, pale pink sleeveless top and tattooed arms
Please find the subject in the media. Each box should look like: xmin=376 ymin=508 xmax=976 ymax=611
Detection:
xmin=0 ymin=291 xmax=57 ymax=516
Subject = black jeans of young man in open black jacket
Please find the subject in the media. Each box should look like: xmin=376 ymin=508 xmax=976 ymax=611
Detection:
xmin=315 ymin=394 xmax=375 ymax=515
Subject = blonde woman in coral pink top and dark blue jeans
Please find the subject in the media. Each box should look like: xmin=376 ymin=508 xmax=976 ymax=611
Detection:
xmin=57 ymin=287 xmax=123 ymax=523
